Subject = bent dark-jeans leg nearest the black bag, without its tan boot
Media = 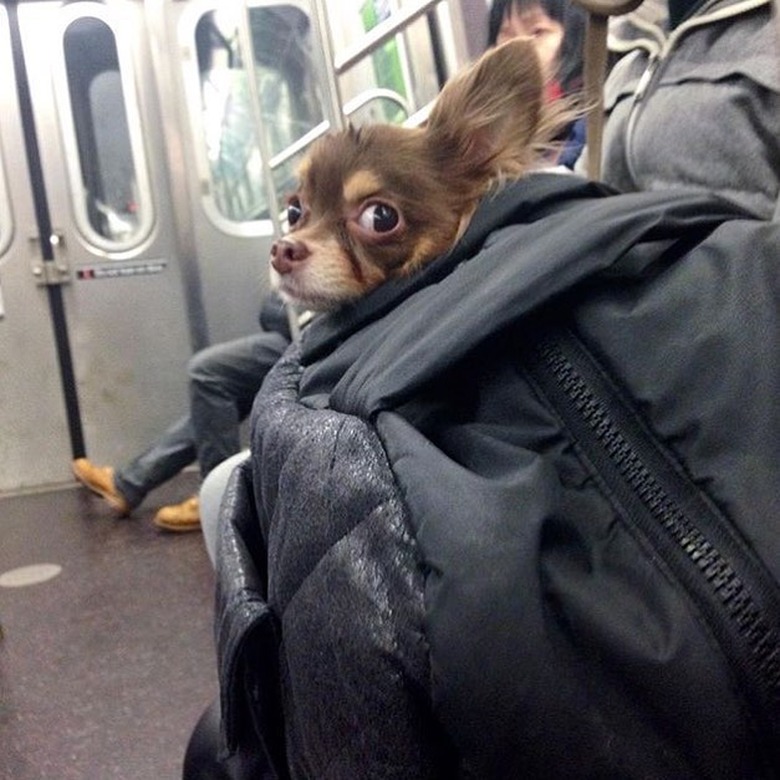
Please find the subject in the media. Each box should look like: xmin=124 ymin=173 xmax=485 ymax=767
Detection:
xmin=189 ymin=332 xmax=289 ymax=477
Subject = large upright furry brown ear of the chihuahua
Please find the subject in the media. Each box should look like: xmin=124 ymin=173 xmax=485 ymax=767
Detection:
xmin=427 ymin=38 xmax=560 ymax=175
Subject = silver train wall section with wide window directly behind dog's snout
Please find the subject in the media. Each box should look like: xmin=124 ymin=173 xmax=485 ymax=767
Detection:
xmin=152 ymin=0 xmax=327 ymax=343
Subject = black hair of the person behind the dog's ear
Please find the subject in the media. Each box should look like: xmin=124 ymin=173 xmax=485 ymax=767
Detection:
xmin=487 ymin=0 xmax=587 ymax=95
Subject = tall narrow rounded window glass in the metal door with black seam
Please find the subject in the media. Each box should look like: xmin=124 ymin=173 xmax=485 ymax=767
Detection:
xmin=63 ymin=16 xmax=143 ymax=244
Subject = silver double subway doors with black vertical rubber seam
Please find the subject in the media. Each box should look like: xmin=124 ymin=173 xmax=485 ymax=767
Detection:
xmin=0 ymin=2 xmax=191 ymax=491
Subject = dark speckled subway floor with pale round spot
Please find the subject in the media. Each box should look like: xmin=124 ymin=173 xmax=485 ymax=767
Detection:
xmin=0 ymin=472 xmax=217 ymax=780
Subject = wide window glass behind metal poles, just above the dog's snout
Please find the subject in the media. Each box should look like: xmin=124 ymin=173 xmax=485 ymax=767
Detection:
xmin=195 ymin=5 xmax=323 ymax=222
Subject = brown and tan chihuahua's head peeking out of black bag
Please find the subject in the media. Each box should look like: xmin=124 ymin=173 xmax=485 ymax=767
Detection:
xmin=271 ymin=39 xmax=571 ymax=311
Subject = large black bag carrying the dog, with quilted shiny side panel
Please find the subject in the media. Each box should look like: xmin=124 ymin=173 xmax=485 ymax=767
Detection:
xmin=206 ymin=175 xmax=780 ymax=778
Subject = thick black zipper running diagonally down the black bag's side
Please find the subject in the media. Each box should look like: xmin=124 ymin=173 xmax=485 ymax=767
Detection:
xmin=527 ymin=329 xmax=780 ymax=767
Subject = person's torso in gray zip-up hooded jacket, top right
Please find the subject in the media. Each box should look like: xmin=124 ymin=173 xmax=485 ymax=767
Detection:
xmin=577 ymin=0 xmax=780 ymax=218
